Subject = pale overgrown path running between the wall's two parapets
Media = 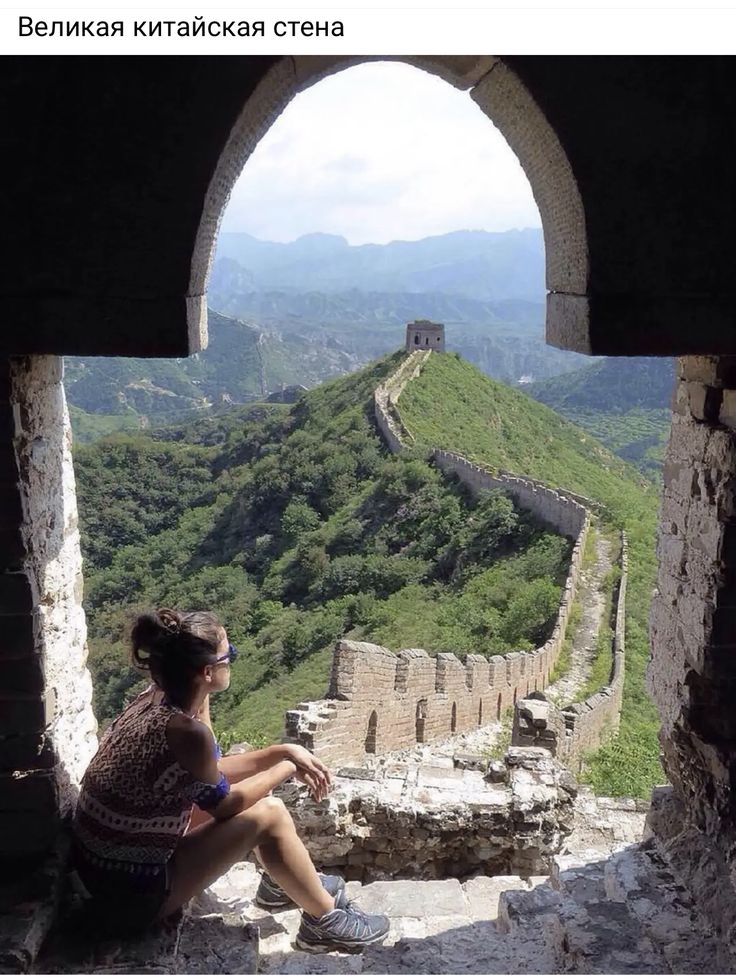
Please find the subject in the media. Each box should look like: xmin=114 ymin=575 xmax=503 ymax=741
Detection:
xmin=545 ymin=525 xmax=613 ymax=706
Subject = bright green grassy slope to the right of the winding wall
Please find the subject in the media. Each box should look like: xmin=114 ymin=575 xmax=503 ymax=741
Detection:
xmin=400 ymin=354 xmax=663 ymax=796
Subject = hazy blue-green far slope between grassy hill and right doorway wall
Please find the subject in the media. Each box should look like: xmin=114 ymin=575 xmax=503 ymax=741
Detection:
xmin=524 ymin=357 xmax=674 ymax=479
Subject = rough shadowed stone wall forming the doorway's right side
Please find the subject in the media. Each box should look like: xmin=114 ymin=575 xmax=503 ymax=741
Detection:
xmin=647 ymin=356 xmax=736 ymax=952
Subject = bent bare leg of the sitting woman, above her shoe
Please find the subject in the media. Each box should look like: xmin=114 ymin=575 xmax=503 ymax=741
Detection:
xmin=160 ymin=797 xmax=335 ymax=917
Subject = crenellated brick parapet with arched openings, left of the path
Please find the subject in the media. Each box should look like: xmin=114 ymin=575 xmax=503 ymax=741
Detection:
xmin=286 ymin=508 xmax=589 ymax=764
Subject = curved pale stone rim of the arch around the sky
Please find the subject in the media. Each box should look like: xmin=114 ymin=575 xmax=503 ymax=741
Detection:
xmin=187 ymin=55 xmax=589 ymax=349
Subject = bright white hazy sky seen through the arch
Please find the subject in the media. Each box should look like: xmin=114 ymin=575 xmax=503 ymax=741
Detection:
xmin=222 ymin=62 xmax=541 ymax=244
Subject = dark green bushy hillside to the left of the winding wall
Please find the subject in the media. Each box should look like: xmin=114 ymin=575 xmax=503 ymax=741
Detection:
xmin=75 ymin=354 xmax=571 ymax=742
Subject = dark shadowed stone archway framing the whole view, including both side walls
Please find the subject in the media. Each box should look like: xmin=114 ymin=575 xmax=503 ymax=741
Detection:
xmin=7 ymin=59 xmax=736 ymax=944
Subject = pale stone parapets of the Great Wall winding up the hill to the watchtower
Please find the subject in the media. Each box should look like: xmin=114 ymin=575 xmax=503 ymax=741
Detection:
xmin=286 ymin=350 xmax=627 ymax=767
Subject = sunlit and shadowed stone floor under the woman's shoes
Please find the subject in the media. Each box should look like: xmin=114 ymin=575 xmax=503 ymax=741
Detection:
xmin=34 ymin=841 xmax=734 ymax=974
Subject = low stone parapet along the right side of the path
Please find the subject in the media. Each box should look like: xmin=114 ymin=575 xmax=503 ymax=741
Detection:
xmin=511 ymin=532 xmax=628 ymax=770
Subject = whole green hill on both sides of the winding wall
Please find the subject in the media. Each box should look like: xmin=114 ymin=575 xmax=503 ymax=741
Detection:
xmin=75 ymin=353 xmax=661 ymax=794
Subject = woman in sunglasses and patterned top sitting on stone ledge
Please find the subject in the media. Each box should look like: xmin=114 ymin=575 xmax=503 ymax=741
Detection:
xmin=73 ymin=609 xmax=389 ymax=952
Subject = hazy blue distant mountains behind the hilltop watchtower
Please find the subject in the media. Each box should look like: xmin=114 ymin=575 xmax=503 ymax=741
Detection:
xmin=66 ymin=229 xmax=604 ymax=440
